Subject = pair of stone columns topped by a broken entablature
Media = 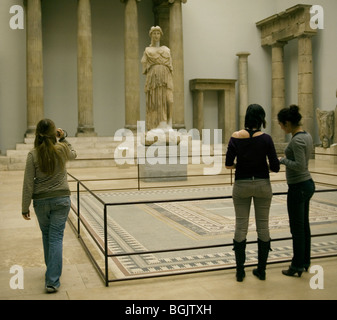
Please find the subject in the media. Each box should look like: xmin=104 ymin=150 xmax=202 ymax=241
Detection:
xmin=256 ymin=4 xmax=317 ymax=151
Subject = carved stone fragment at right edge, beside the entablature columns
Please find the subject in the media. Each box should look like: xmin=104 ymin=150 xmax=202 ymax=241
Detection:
xmin=316 ymin=109 xmax=335 ymax=148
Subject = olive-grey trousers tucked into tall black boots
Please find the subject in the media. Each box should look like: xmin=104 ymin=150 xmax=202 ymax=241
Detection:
xmin=233 ymin=179 xmax=273 ymax=242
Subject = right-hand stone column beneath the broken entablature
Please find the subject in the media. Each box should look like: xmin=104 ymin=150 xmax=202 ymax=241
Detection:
xmin=298 ymin=35 xmax=314 ymax=135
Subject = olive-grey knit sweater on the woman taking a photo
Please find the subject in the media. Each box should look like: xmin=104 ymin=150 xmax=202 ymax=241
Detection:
xmin=22 ymin=139 xmax=76 ymax=213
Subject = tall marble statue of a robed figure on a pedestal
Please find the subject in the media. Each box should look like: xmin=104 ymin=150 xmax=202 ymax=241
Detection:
xmin=141 ymin=26 xmax=173 ymax=131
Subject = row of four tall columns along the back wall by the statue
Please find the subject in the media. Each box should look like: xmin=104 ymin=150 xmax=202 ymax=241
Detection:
xmin=26 ymin=0 xmax=187 ymax=136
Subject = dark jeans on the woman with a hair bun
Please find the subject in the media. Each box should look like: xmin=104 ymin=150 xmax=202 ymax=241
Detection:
xmin=287 ymin=179 xmax=315 ymax=268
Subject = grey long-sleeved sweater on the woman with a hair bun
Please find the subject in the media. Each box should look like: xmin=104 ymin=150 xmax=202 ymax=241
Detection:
xmin=280 ymin=132 xmax=313 ymax=184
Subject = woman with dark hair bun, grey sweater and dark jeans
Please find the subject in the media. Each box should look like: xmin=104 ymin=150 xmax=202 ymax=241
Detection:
xmin=277 ymin=105 xmax=315 ymax=277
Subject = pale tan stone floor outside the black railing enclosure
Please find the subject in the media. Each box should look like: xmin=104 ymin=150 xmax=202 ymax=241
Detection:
xmin=0 ymin=161 xmax=337 ymax=300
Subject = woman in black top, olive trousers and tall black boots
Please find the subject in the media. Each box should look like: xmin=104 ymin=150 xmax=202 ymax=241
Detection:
xmin=226 ymin=104 xmax=280 ymax=282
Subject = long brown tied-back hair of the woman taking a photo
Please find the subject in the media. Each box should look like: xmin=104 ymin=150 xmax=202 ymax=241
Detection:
xmin=34 ymin=119 xmax=65 ymax=175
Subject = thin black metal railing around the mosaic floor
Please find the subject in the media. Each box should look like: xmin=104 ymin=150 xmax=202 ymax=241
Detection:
xmin=68 ymin=152 xmax=337 ymax=286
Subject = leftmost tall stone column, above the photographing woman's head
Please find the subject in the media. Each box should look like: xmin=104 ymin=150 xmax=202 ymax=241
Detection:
xmin=26 ymin=0 xmax=44 ymax=136
